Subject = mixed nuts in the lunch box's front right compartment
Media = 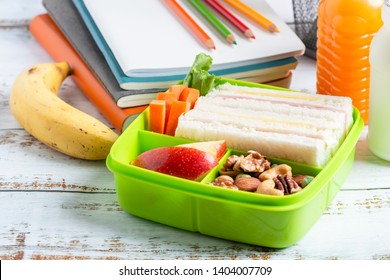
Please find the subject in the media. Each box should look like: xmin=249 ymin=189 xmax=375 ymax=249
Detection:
xmin=210 ymin=151 xmax=313 ymax=196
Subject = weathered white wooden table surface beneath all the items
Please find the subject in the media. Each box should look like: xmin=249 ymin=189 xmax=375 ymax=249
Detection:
xmin=0 ymin=0 xmax=390 ymax=260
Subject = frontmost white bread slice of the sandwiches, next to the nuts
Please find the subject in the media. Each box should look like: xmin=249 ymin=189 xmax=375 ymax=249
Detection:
xmin=176 ymin=119 xmax=330 ymax=166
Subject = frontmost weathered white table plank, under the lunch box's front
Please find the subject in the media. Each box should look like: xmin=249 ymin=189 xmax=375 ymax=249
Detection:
xmin=0 ymin=190 xmax=390 ymax=260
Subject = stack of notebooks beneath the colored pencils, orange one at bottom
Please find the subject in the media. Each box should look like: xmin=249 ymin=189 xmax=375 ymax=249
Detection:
xmin=30 ymin=0 xmax=305 ymax=132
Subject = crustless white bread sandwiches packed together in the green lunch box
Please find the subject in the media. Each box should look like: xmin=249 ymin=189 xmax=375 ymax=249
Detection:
xmin=175 ymin=84 xmax=353 ymax=167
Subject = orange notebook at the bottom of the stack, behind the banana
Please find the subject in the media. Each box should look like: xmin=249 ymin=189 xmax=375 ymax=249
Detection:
xmin=29 ymin=14 xmax=147 ymax=133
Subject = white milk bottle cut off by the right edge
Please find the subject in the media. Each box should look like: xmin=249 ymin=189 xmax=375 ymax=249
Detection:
xmin=367 ymin=0 xmax=390 ymax=161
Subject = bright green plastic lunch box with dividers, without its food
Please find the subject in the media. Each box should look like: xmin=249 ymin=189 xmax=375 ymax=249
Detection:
xmin=107 ymin=79 xmax=364 ymax=248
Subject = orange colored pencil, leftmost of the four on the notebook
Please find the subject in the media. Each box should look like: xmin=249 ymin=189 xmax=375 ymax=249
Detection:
xmin=165 ymin=0 xmax=216 ymax=49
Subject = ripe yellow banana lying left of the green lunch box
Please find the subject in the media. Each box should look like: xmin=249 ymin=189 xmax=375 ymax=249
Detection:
xmin=10 ymin=62 xmax=118 ymax=160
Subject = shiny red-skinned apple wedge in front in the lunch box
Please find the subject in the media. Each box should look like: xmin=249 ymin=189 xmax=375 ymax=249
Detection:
xmin=132 ymin=146 xmax=218 ymax=181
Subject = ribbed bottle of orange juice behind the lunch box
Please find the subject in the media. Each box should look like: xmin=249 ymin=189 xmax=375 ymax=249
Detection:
xmin=317 ymin=0 xmax=383 ymax=124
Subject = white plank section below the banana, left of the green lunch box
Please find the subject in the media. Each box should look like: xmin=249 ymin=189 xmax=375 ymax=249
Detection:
xmin=0 ymin=130 xmax=115 ymax=192
